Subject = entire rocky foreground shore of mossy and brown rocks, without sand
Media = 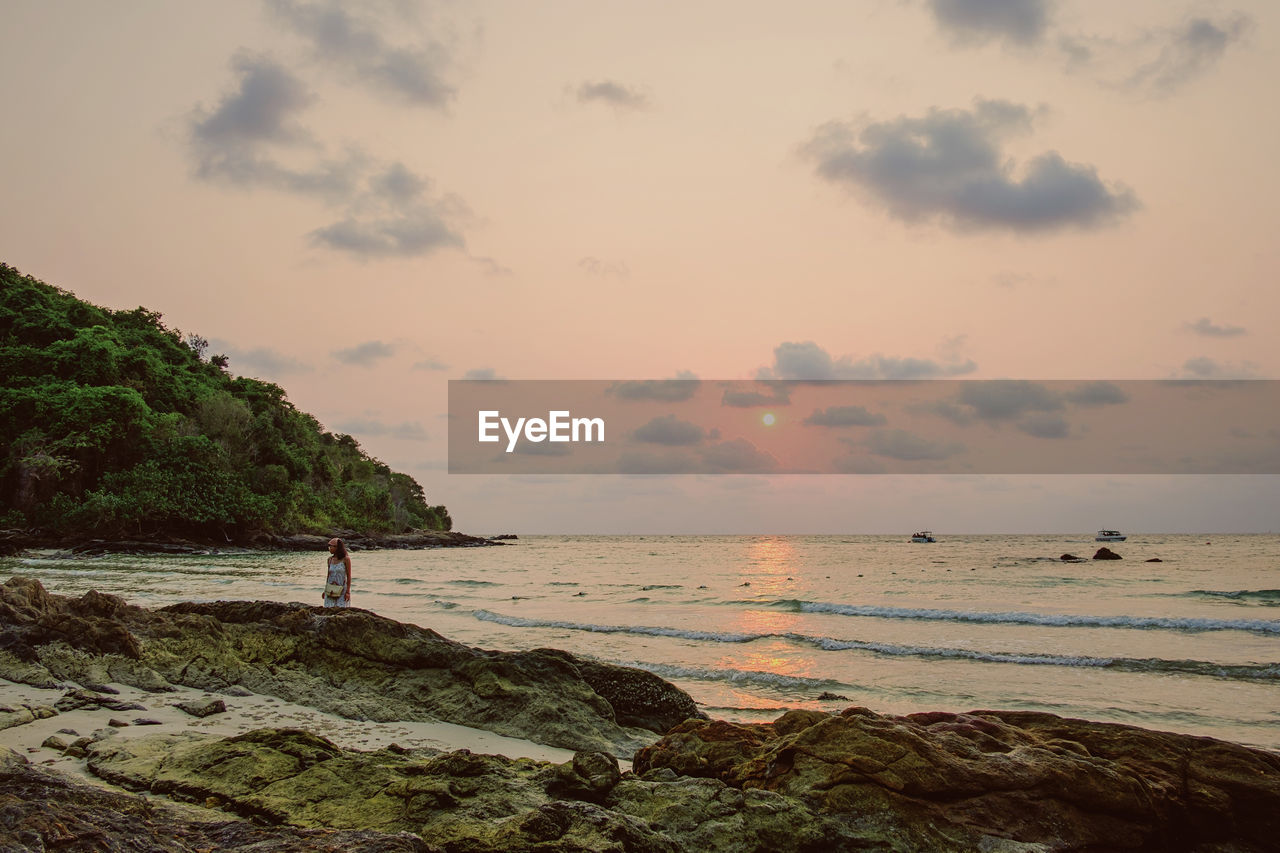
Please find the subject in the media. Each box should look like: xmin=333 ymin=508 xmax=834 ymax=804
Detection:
xmin=0 ymin=578 xmax=1280 ymax=853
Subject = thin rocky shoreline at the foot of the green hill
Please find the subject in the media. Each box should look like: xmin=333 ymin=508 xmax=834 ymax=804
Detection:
xmin=0 ymin=530 xmax=499 ymax=557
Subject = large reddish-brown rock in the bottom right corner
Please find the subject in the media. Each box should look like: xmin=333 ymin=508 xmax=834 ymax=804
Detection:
xmin=634 ymin=708 xmax=1280 ymax=850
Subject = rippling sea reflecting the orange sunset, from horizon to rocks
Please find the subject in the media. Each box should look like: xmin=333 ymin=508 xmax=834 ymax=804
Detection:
xmin=0 ymin=534 xmax=1280 ymax=751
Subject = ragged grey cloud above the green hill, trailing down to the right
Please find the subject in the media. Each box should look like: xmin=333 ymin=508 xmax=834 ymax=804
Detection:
xmin=188 ymin=54 xmax=465 ymax=259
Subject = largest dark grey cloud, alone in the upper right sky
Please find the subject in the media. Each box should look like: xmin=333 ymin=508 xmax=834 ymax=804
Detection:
xmin=801 ymin=100 xmax=1138 ymax=233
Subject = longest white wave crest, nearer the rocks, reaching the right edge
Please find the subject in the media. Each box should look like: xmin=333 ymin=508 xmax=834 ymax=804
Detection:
xmin=474 ymin=610 xmax=1280 ymax=681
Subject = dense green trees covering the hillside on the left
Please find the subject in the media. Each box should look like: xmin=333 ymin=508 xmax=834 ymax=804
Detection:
xmin=0 ymin=264 xmax=452 ymax=538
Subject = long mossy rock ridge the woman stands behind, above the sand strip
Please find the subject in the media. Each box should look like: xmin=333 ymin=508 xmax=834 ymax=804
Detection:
xmin=0 ymin=578 xmax=703 ymax=756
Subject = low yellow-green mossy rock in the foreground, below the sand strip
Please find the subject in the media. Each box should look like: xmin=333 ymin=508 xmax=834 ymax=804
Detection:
xmin=88 ymin=729 xmax=860 ymax=853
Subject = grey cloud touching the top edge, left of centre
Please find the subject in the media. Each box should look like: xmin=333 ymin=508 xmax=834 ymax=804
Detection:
xmin=266 ymin=0 xmax=456 ymax=109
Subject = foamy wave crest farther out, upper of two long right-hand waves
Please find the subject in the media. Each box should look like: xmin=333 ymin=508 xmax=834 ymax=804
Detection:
xmin=762 ymin=598 xmax=1280 ymax=634
